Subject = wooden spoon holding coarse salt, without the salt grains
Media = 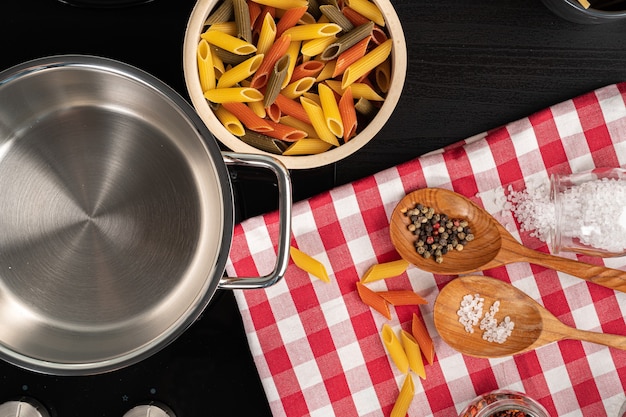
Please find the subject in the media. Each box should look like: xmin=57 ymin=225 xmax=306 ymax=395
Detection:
xmin=434 ymin=275 xmax=626 ymax=358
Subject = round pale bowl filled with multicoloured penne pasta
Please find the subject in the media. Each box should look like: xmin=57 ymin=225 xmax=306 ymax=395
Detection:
xmin=183 ymin=0 xmax=407 ymax=169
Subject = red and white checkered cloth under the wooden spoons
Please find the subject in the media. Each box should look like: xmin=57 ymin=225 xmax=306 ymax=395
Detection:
xmin=227 ymin=83 xmax=626 ymax=417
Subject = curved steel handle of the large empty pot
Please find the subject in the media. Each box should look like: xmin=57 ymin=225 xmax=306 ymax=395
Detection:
xmin=218 ymin=152 xmax=292 ymax=290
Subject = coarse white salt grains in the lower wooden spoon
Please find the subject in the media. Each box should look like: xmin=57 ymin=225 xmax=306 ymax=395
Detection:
xmin=457 ymin=294 xmax=515 ymax=343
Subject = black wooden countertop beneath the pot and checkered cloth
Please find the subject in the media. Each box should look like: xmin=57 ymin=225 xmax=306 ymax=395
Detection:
xmin=0 ymin=0 xmax=626 ymax=417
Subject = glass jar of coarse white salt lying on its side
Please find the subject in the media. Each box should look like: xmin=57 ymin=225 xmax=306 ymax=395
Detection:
xmin=548 ymin=168 xmax=626 ymax=257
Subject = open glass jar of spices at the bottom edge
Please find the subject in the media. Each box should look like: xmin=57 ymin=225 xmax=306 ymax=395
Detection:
xmin=459 ymin=390 xmax=550 ymax=417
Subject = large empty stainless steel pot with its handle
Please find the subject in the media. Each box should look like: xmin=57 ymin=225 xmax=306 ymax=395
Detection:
xmin=0 ymin=55 xmax=291 ymax=375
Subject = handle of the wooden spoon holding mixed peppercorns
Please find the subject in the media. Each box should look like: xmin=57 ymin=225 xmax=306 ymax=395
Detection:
xmin=498 ymin=237 xmax=626 ymax=292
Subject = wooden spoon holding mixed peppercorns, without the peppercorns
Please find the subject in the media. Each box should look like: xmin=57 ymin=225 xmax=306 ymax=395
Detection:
xmin=390 ymin=188 xmax=626 ymax=292
